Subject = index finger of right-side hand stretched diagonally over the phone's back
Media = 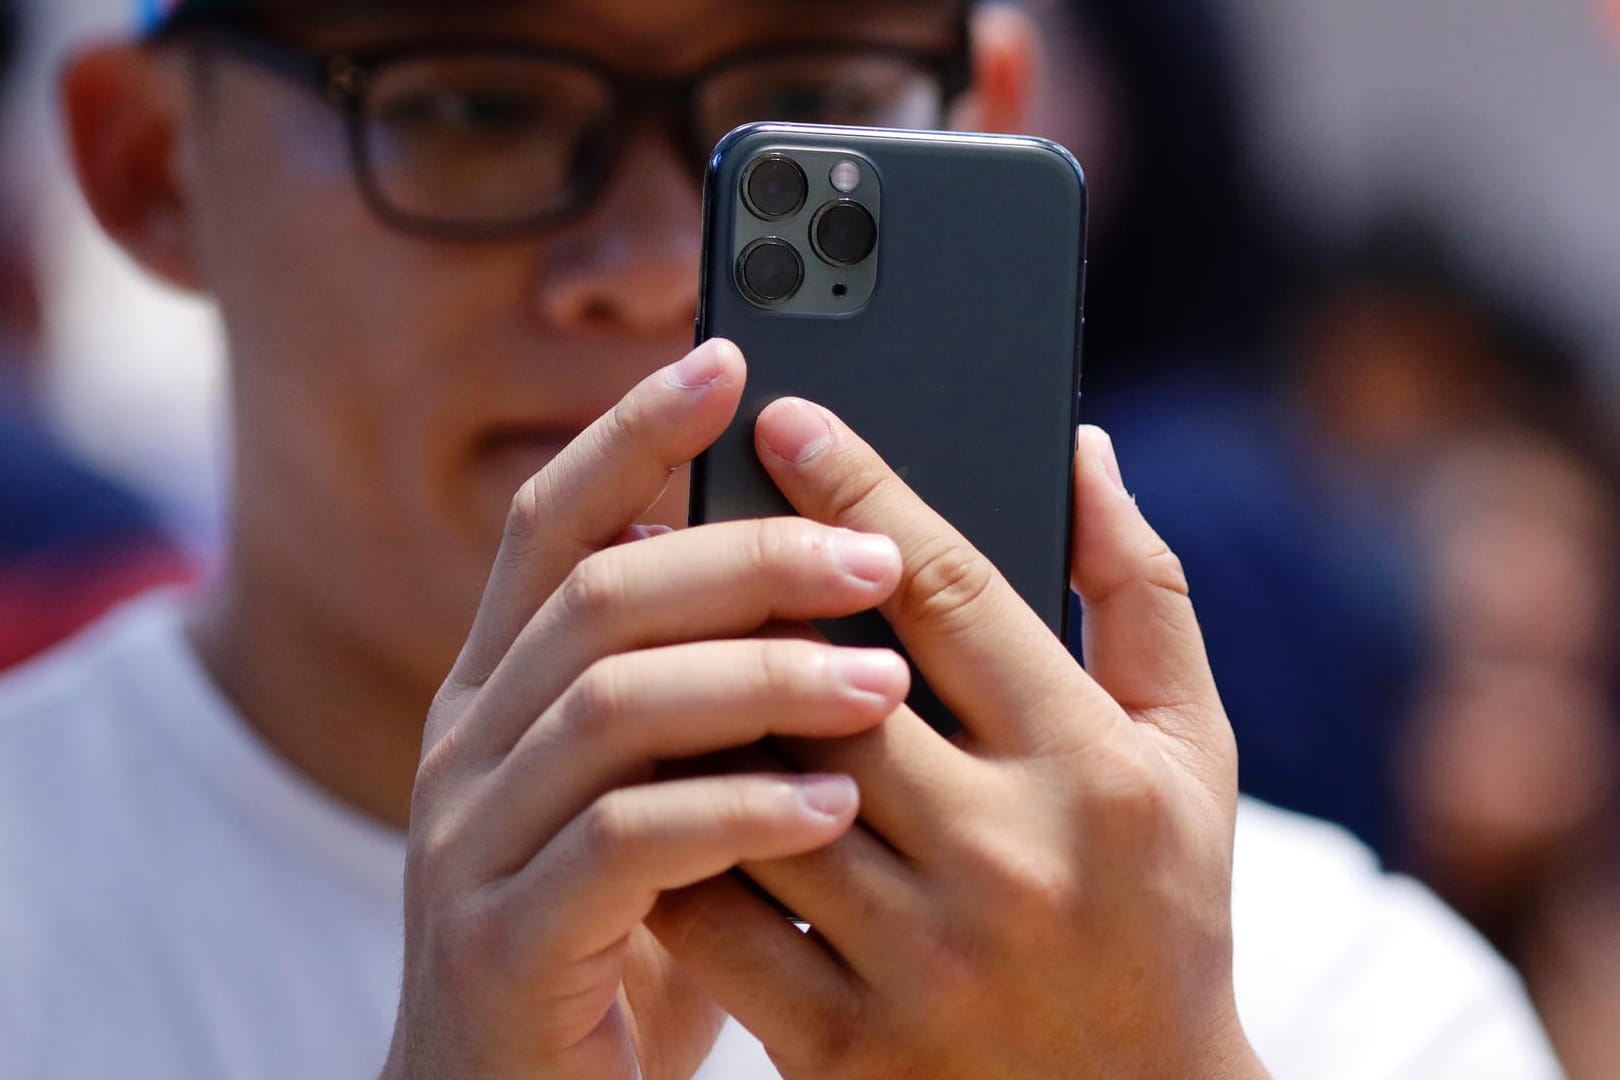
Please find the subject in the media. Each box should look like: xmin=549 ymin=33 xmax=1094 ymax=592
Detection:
xmin=757 ymin=398 xmax=1121 ymax=748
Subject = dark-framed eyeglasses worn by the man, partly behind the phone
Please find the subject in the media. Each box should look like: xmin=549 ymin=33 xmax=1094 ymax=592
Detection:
xmin=177 ymin=24 xmax=969 ymax=240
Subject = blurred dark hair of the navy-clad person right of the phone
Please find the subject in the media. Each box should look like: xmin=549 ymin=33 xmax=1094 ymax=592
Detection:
xmin=1069 ymin=0 xmax=1293 ymax=389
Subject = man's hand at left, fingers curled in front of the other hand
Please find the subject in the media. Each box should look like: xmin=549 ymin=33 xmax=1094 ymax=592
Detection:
xmin=384 ymin=342 xmax=909 ymax=1080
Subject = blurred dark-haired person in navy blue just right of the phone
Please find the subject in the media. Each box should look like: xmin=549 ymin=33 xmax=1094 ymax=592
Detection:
xmin=1027 ymin=0 xmax=1418 ymax=857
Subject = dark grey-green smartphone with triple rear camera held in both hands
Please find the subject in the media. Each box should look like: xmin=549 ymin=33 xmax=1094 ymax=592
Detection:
xmin=690 ymin=123 xmax=1085 ymax=732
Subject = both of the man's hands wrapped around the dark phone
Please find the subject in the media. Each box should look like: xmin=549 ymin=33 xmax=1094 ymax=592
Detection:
xmin=384 ymin=343 xmax=1264 ymax=1080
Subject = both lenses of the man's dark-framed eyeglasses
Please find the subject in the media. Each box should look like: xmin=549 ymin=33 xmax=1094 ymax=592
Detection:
xmin=361 ymin=53 xmax=943 ymax=228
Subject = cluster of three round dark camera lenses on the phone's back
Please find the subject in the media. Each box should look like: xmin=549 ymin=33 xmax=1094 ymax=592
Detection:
xmin=737 ymin=152 xmax=878 ymax=306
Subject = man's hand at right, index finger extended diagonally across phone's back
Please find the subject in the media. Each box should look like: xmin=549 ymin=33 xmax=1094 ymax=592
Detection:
xmin=650 ymin=400 xmax=1264 ymax=1080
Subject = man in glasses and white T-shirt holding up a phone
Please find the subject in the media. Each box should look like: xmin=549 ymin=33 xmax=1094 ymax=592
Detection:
xmin=0 ymin=0 xmax=1557 ymax=1078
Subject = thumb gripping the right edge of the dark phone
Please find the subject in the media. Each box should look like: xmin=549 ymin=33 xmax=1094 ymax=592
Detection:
xmin=1071 ymin=426 xmax=1231 ymax=746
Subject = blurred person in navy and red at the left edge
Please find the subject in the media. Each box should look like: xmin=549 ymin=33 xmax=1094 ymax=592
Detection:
xmin=0 ymin=0 xmax=190 ymax=667
